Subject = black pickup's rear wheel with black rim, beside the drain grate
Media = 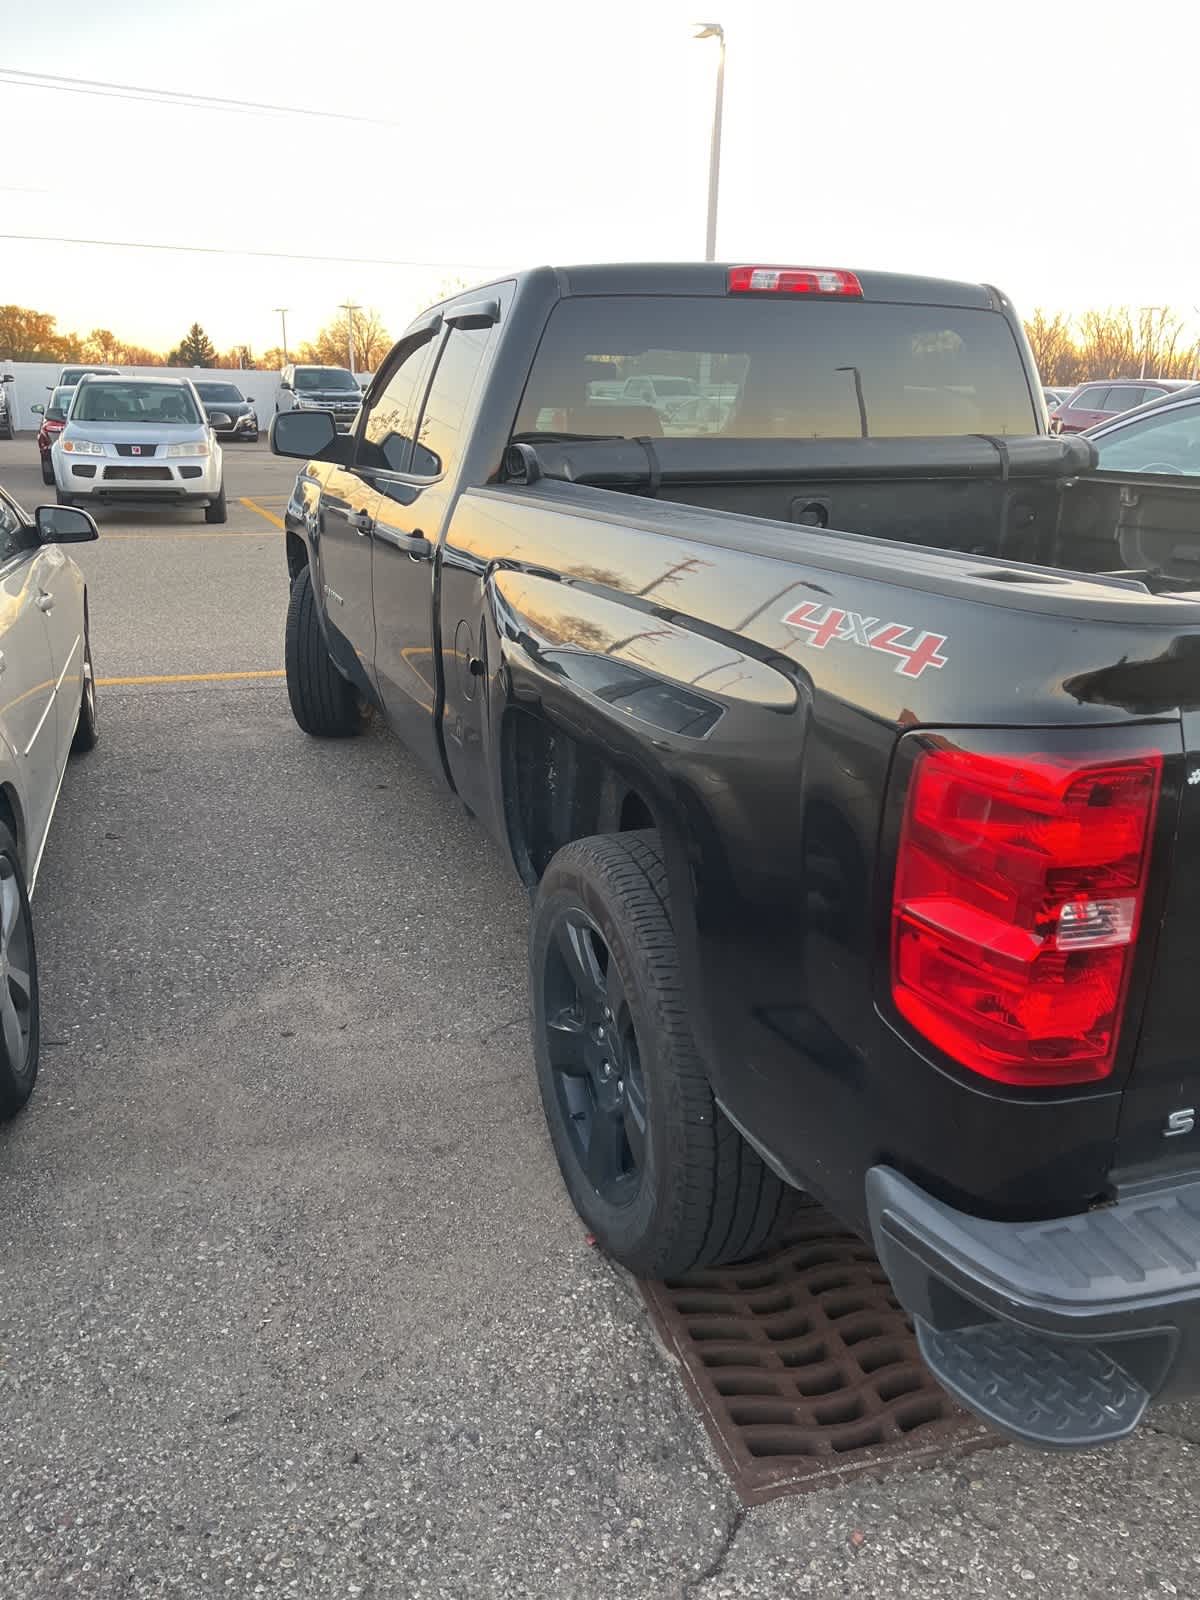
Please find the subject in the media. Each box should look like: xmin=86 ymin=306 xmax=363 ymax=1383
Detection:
xmin=530 ymin=832 xmax=787 ymax=1278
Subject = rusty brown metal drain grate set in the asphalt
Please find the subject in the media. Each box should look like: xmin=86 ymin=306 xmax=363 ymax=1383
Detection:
xmin=642 ymin=1205 xmax=998 ymax=1504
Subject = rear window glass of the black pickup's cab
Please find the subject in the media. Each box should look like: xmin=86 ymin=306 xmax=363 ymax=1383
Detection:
xmin=515 ymin=294 xmax=1038 ymax=438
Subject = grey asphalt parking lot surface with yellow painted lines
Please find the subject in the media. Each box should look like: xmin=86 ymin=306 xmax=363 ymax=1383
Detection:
xmin=0 ymin=438 xmax=1200 ymax=1600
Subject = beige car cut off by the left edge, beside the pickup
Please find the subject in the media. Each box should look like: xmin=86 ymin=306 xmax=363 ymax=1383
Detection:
xmin=0 ymin=490 xmax=98 ymax=1118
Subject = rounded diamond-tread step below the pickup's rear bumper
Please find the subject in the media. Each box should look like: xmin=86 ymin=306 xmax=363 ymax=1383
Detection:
xmin=915 ymin=1317 xmax=1150 ymax=1450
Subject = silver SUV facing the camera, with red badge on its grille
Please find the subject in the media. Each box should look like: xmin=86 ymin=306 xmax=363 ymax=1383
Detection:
xmin=50 ymin=378 xmax=227 ymax=523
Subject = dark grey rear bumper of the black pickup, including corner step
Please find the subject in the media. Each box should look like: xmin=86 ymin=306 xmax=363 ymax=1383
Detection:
xmin=867 ymin=1166 xmax=1200 ymax=1448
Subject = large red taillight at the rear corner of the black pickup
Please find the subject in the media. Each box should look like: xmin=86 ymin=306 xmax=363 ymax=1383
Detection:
xmin=891 ymin=749 xmax=1162 ymax=1083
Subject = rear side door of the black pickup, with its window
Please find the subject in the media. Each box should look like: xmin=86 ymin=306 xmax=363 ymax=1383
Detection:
xmin=368 ymin=307 xmax=493 ymax=771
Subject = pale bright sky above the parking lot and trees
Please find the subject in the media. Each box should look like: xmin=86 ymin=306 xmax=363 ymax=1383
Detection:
xmin=0 ymin=0 xmax=1200 ymax=350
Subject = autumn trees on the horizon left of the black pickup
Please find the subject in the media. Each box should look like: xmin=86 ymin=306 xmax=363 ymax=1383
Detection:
xmin=0 ymin=306 xmax=392 ymax=373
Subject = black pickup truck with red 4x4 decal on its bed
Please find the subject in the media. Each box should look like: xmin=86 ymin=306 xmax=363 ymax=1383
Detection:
xmin=272 ymin=264 xmax=1200 ymax=1445
